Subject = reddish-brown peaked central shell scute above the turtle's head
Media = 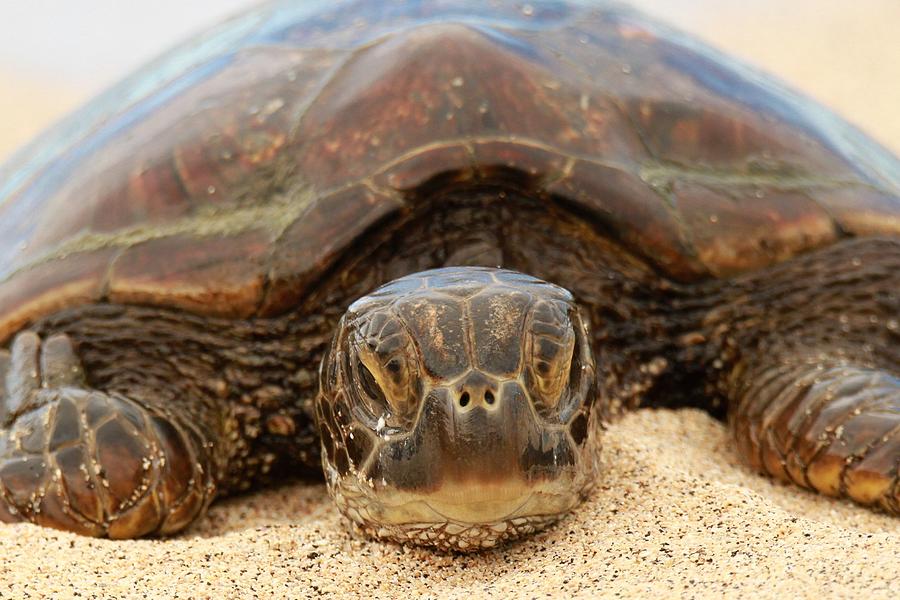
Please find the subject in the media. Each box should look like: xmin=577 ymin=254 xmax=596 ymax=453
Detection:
xmin=298 ymin=24 xmax=646 ymax=189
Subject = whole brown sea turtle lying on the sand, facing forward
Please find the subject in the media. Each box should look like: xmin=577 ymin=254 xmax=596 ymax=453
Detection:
xmin=0 ymin=0 xmax=900 ymax=550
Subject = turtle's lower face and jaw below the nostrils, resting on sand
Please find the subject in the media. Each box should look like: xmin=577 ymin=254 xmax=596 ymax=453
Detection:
xmin=326 ymin=385 xmax=596 ymax=551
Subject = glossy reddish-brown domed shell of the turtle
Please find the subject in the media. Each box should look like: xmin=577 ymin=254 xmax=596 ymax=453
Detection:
xmin=0 ymin=0 xmax=900 ymax=341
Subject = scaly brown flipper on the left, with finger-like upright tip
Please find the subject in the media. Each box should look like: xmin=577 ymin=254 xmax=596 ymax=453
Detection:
xmin=0 ymin=331 xmax=215 ymax=538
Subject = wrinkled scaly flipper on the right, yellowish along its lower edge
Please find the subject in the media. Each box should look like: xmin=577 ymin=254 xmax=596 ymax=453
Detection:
xmin=719 ymin=240 xmax=900 ymax=515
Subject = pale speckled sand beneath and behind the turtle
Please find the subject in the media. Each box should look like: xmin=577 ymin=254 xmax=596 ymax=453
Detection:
xmin=0 ymin=0 xmax=900 ymax=599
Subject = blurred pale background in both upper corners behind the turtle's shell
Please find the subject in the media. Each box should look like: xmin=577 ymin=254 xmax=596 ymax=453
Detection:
xmin=0 ymin=0 xmax=900 ymax=160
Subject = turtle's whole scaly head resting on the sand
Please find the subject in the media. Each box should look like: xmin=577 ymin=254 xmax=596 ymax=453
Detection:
xmin=316 ymin=267 xmax=597 ymax=550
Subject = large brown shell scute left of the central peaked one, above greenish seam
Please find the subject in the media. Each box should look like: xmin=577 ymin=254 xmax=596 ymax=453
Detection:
xmin=0 ymin=49 xmax=342 ymax=276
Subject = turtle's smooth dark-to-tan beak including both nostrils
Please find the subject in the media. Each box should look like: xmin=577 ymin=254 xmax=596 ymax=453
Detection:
xmin=370 ymin=380 xmax=578 ymax=524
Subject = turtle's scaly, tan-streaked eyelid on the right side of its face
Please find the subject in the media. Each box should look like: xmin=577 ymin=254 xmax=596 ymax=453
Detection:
xmin=528 ymin=304 xmax=575 ymax=408
